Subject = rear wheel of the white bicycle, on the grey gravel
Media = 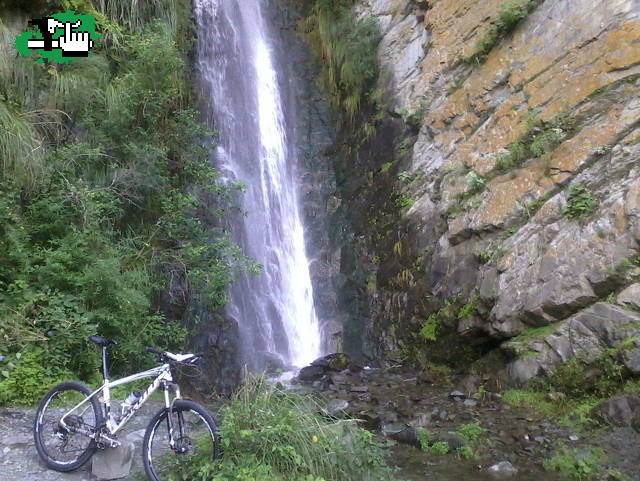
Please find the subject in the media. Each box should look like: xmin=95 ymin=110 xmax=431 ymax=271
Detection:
xmin=33 ymin=381 xmax=103 ymax=473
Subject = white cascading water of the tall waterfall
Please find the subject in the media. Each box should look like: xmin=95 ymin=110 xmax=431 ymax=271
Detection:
xmin=195 ymin=0 xmax=321 ymax=369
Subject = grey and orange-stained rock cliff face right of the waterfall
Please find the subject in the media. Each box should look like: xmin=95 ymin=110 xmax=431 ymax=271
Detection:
xmin=334 ymin=0 xmax=640 ymax=381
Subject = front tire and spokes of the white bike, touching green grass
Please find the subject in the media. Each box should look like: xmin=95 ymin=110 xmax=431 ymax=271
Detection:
xmin=142 ymin=399 xmax=220 ymax=481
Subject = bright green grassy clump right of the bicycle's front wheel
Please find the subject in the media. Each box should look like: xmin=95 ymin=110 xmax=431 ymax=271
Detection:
xmin=165 ymin=378 xmax=391 ymax=481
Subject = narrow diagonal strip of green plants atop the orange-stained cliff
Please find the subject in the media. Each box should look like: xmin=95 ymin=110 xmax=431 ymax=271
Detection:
xmin=462 ymin=0 xmax=540 ymax=63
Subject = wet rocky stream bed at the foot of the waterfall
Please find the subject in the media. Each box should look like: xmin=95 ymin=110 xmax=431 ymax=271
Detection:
xmin=300 ymin=352 xmax=640 ymax=481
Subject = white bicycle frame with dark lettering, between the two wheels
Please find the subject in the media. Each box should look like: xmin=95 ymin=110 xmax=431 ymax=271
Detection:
xmin=60 ymin=364 xmax=182 ymax=442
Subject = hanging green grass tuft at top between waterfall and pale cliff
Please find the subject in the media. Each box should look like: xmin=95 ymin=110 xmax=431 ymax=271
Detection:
xmin=303 ymin=0 xmax=380 ymax=121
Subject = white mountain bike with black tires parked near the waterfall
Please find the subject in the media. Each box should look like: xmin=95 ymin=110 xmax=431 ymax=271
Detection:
xmin=33 ymin=336 xmax=220 ymax=481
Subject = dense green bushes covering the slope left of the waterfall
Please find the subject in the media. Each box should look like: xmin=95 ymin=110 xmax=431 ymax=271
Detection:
xmin=0 ymin=0 xmax=254 ymax=403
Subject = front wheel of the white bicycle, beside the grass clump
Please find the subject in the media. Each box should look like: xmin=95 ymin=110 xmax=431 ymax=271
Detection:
xmin=142 ymin=399 xmax=220 ymax=481
